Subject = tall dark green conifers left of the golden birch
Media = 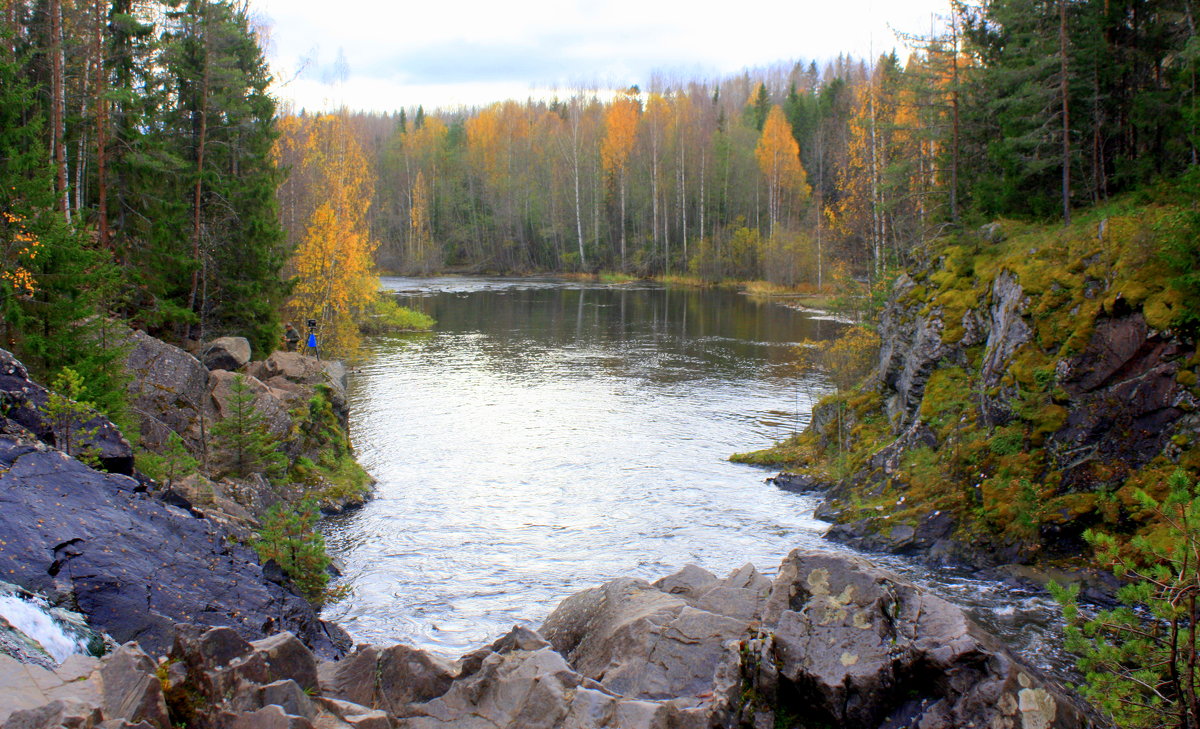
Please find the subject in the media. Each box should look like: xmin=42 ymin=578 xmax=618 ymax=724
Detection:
xmin=0 ymin=0 xmax=289 ymax=392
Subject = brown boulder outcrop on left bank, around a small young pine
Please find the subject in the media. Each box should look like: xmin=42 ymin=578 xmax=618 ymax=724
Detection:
xmin=126 ymin=331 xmax=371 ymax=526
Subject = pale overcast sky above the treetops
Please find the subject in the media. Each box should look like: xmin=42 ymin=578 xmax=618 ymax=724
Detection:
xmin=251 ymin=0 xmax=948 ymax=112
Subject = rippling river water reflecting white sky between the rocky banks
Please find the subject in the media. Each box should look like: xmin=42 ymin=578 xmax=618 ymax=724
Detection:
xmin=323 ymin=278 xmax=1061 ymax=669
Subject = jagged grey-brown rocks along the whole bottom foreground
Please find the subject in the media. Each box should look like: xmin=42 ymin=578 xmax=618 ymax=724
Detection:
xmin=0 ymin=552 xmax=1102 ymax=729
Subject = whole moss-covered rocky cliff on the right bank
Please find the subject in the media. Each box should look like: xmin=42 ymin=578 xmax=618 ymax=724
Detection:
xmin=757 ymin=207 xmax=1200 ymax=575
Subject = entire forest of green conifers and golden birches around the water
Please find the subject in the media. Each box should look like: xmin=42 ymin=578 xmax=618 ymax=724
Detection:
xmin=0 ymin=0 xmax=1200 ymax=400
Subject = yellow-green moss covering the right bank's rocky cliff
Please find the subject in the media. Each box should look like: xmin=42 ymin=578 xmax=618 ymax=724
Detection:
xmin=737 ymin=198 xmax=1200 ymax=565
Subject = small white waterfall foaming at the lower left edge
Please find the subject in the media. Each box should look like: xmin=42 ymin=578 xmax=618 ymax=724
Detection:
xmin=0 ymin=583 xmax=103 ymax=665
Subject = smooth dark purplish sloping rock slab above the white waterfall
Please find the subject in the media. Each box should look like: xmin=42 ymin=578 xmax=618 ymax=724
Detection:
xmin=0 ymin=428 xmax=348 ymax=656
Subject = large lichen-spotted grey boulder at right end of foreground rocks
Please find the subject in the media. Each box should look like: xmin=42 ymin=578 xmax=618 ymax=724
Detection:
xmin=756 ymin=550 xmax=1093 ymax=727
